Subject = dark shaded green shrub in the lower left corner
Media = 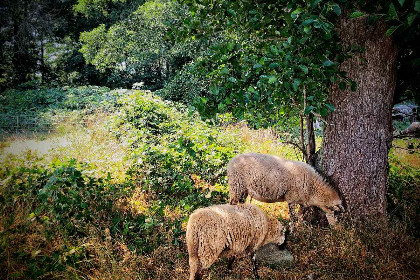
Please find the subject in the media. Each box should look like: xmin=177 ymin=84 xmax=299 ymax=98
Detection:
xmin=0 ymin=160 xmax=162 ymax=279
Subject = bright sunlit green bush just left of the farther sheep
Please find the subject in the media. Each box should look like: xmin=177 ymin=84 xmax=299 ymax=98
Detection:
xmin=110 ymin=91 xmax=240 ymax=207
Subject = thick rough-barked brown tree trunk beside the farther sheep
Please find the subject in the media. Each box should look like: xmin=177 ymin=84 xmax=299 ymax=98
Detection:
xmin=322 ymin=16 xmax=397 ymax=220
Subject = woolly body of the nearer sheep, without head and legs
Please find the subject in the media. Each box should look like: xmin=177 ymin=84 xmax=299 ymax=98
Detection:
xmin=187 ymin=204 xmax=268 ymax=267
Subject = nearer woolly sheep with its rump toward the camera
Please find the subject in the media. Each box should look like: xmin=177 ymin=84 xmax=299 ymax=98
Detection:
xmin=186 ymin=204 xmax=285 ymax=280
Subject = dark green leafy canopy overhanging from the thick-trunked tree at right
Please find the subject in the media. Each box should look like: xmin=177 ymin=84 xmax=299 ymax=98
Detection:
xmin=174 ymin=0 xmax=418 ymax=125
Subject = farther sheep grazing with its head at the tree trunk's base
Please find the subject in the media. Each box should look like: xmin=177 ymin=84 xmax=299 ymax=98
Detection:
xmin=227 ymin=153 xmax=344 ymax=225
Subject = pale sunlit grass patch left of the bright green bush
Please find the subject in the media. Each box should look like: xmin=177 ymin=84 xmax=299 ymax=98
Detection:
xmin=1 ymin=114 xmax=130 ymax=182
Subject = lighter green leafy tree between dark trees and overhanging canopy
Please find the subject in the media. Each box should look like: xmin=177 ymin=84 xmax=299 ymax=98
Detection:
xmin=76 ymin=1 xmax=190 ymax=89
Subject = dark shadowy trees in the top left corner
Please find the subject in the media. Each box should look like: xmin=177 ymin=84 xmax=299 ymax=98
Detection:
xmin=0 ymin=0 xmax=113 ymax=90
